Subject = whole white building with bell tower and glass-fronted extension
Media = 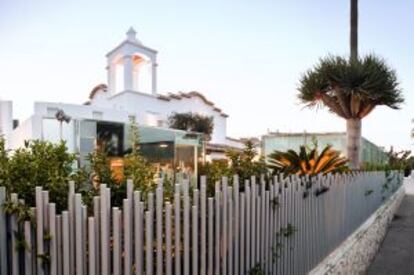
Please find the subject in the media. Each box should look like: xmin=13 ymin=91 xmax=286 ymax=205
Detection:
xmin=4 ymin=28 xmax=242 ymax=179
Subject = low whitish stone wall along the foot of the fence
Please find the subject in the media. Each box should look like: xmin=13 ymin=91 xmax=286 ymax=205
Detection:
xmin=309 ymin=182 xmax=406 ymax=275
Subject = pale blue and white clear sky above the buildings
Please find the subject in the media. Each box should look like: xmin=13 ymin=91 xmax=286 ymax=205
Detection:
xmin=0 ymin=0 xmax=414 ymax=149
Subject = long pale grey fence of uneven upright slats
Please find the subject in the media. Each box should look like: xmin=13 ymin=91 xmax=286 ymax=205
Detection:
xmin=0 ymin=172 xmax=403 ymax=275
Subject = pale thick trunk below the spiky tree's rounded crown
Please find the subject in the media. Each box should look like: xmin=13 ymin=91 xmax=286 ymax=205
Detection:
xmin=346 ymin=118 xmax=361 ymax=169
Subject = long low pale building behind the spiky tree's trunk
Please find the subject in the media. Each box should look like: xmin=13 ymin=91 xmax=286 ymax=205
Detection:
xmin=262 ymin=132 xmax=388 ymax=163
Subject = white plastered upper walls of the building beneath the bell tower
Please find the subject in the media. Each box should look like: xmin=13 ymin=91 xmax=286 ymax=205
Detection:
xmin=11 ymin=91 xmax=230 ymax=151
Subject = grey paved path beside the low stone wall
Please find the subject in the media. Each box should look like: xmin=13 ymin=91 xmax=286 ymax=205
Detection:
xmin=367 ymin=182 xmax=414 ymax=275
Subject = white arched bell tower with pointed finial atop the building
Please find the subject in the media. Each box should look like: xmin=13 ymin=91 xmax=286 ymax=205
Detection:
xmin=106 ymin=27 xmax=157 ymax=95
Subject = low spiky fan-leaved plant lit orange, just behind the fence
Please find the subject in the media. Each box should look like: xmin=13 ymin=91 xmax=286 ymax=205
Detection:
xmin=268 ymin=145 xmax=348 ymax=175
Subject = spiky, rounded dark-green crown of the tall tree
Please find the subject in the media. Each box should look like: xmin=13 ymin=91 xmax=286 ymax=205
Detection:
xmin=298 ymin=55 xmax=404 ymax=119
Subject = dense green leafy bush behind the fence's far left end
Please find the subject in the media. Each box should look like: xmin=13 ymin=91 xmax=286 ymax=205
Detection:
xmin=0 ymin=138 xmax=78 ymax=211
